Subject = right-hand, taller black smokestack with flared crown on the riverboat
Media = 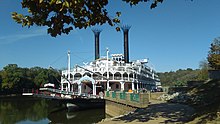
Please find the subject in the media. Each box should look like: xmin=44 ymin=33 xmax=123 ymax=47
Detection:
xmin=121 ymin=25 xmax=131 ymax=63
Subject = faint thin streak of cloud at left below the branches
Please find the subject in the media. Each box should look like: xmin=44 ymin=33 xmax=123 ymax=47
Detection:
xmin=0 ymin=28 xmax=47 ymax=44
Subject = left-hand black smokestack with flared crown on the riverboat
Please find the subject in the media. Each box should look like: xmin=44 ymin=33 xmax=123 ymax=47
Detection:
xmin=92 ymin=29 xmax=101 ymax=60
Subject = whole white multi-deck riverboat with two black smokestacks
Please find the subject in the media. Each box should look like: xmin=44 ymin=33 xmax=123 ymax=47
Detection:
xmin=61 ymin=26 xmax=161 ymax=96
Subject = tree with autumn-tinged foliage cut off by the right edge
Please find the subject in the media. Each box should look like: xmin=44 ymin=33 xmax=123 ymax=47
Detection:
xmin=207 ymin=37 xmax=220 ymax=70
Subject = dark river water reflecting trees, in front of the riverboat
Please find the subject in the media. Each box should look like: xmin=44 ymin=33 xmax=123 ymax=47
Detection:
xmin=0 ymin=96 xmax=105 ymax=124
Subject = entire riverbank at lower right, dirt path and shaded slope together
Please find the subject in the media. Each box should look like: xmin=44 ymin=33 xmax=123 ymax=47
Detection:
xmin=99 ymin=80 xmax=220 ymax=124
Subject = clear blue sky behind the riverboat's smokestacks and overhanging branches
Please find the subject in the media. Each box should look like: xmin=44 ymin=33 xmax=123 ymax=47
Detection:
xmin=0 ymin=0 xmax=220 ymax=72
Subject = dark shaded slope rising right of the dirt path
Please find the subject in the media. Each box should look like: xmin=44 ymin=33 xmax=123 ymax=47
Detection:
xmin=170 ymin=80 xmax=220 ymax=123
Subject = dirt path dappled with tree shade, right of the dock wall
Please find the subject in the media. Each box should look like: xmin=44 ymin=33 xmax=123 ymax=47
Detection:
xmin=100 ymin=103 xmax=195 ymax=124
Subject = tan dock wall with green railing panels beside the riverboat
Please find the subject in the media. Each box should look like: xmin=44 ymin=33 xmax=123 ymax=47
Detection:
xmin=104 ymin=91 xmax=150 ymax=116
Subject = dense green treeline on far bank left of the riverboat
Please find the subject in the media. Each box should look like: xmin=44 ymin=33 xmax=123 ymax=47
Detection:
xmin=0 ymin=64 xmax=61 ymax=94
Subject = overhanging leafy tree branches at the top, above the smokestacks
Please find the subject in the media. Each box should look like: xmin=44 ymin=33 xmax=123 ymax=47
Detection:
xmin=12 ymin=0 xmax=163 ymax=37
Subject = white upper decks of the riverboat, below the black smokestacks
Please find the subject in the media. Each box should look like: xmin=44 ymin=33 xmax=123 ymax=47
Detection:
xmin=62 ymin=54 xmax=159 ymax=82
